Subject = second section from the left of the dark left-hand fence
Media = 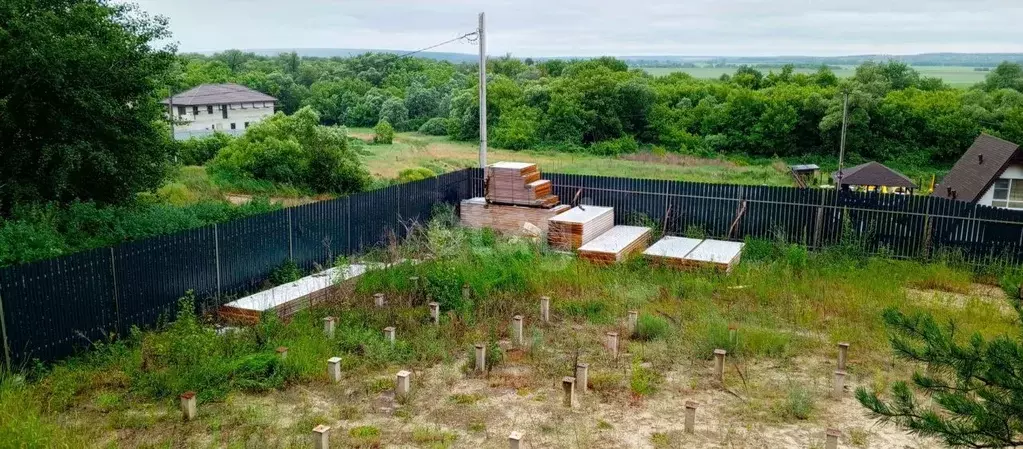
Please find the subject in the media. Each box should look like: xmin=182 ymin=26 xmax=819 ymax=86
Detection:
xmin=114 ymin=226 xmax=217 ymax=334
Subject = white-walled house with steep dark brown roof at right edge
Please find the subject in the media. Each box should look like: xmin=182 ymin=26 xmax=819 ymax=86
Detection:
xmin=931 ymin=134 xmax=1023 ymax=209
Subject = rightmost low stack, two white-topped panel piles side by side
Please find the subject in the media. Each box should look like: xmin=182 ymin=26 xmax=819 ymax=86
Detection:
xmin=643 ymin=236 xmax=743 ymax=272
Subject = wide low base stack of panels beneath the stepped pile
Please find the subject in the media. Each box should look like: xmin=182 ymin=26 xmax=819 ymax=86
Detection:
xmin=460 ymin=197 xmax=569 ymax=235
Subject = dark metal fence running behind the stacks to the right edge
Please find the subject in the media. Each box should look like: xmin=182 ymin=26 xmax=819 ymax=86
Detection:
xmin=471 ymin=169 xmax=1023 ymax=265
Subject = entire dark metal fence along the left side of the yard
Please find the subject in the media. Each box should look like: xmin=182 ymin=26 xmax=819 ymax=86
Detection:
xmin=0 ymin=170 xmax=470 ymax=366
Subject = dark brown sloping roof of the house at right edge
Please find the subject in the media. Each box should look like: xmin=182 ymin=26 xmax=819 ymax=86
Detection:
xmin=931 ymin=134 xmax=1020 ymax=203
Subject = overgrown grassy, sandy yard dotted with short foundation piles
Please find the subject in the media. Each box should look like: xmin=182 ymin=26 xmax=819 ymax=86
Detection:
xmin=0 ymin=215 xmax=1019 ymax=448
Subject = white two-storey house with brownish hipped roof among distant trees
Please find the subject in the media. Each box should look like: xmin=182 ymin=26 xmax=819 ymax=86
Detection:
xmin=163 ymin=83 xmax=277 ymax=138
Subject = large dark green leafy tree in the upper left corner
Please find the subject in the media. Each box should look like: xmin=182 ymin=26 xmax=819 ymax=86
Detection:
xmin=0 ymin=0 xmax=174 ymax=213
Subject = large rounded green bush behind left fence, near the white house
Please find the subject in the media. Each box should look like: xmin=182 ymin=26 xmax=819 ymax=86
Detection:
xmin=210 ymin=106 xmax=369 ymax=193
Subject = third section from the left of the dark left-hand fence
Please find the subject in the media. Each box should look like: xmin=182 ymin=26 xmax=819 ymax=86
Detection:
xmin=217 ymin=210 xmax=290 ymax=297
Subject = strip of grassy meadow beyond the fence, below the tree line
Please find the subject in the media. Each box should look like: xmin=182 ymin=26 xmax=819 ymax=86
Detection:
xmin=349 ymin=128 xmax=792 ymax=185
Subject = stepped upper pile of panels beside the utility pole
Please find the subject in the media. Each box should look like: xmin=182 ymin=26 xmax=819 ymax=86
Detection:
xmin=487 ymin=163 xmax=558 ymax=208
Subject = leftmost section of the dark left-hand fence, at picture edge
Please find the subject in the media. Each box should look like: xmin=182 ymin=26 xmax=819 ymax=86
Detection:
xmin=0 ymin=248 xmax=118 ymax=367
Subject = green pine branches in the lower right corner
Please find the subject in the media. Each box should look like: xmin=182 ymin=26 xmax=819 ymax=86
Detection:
xmin=856 ymin=308 xmax=1023 ymax=448
